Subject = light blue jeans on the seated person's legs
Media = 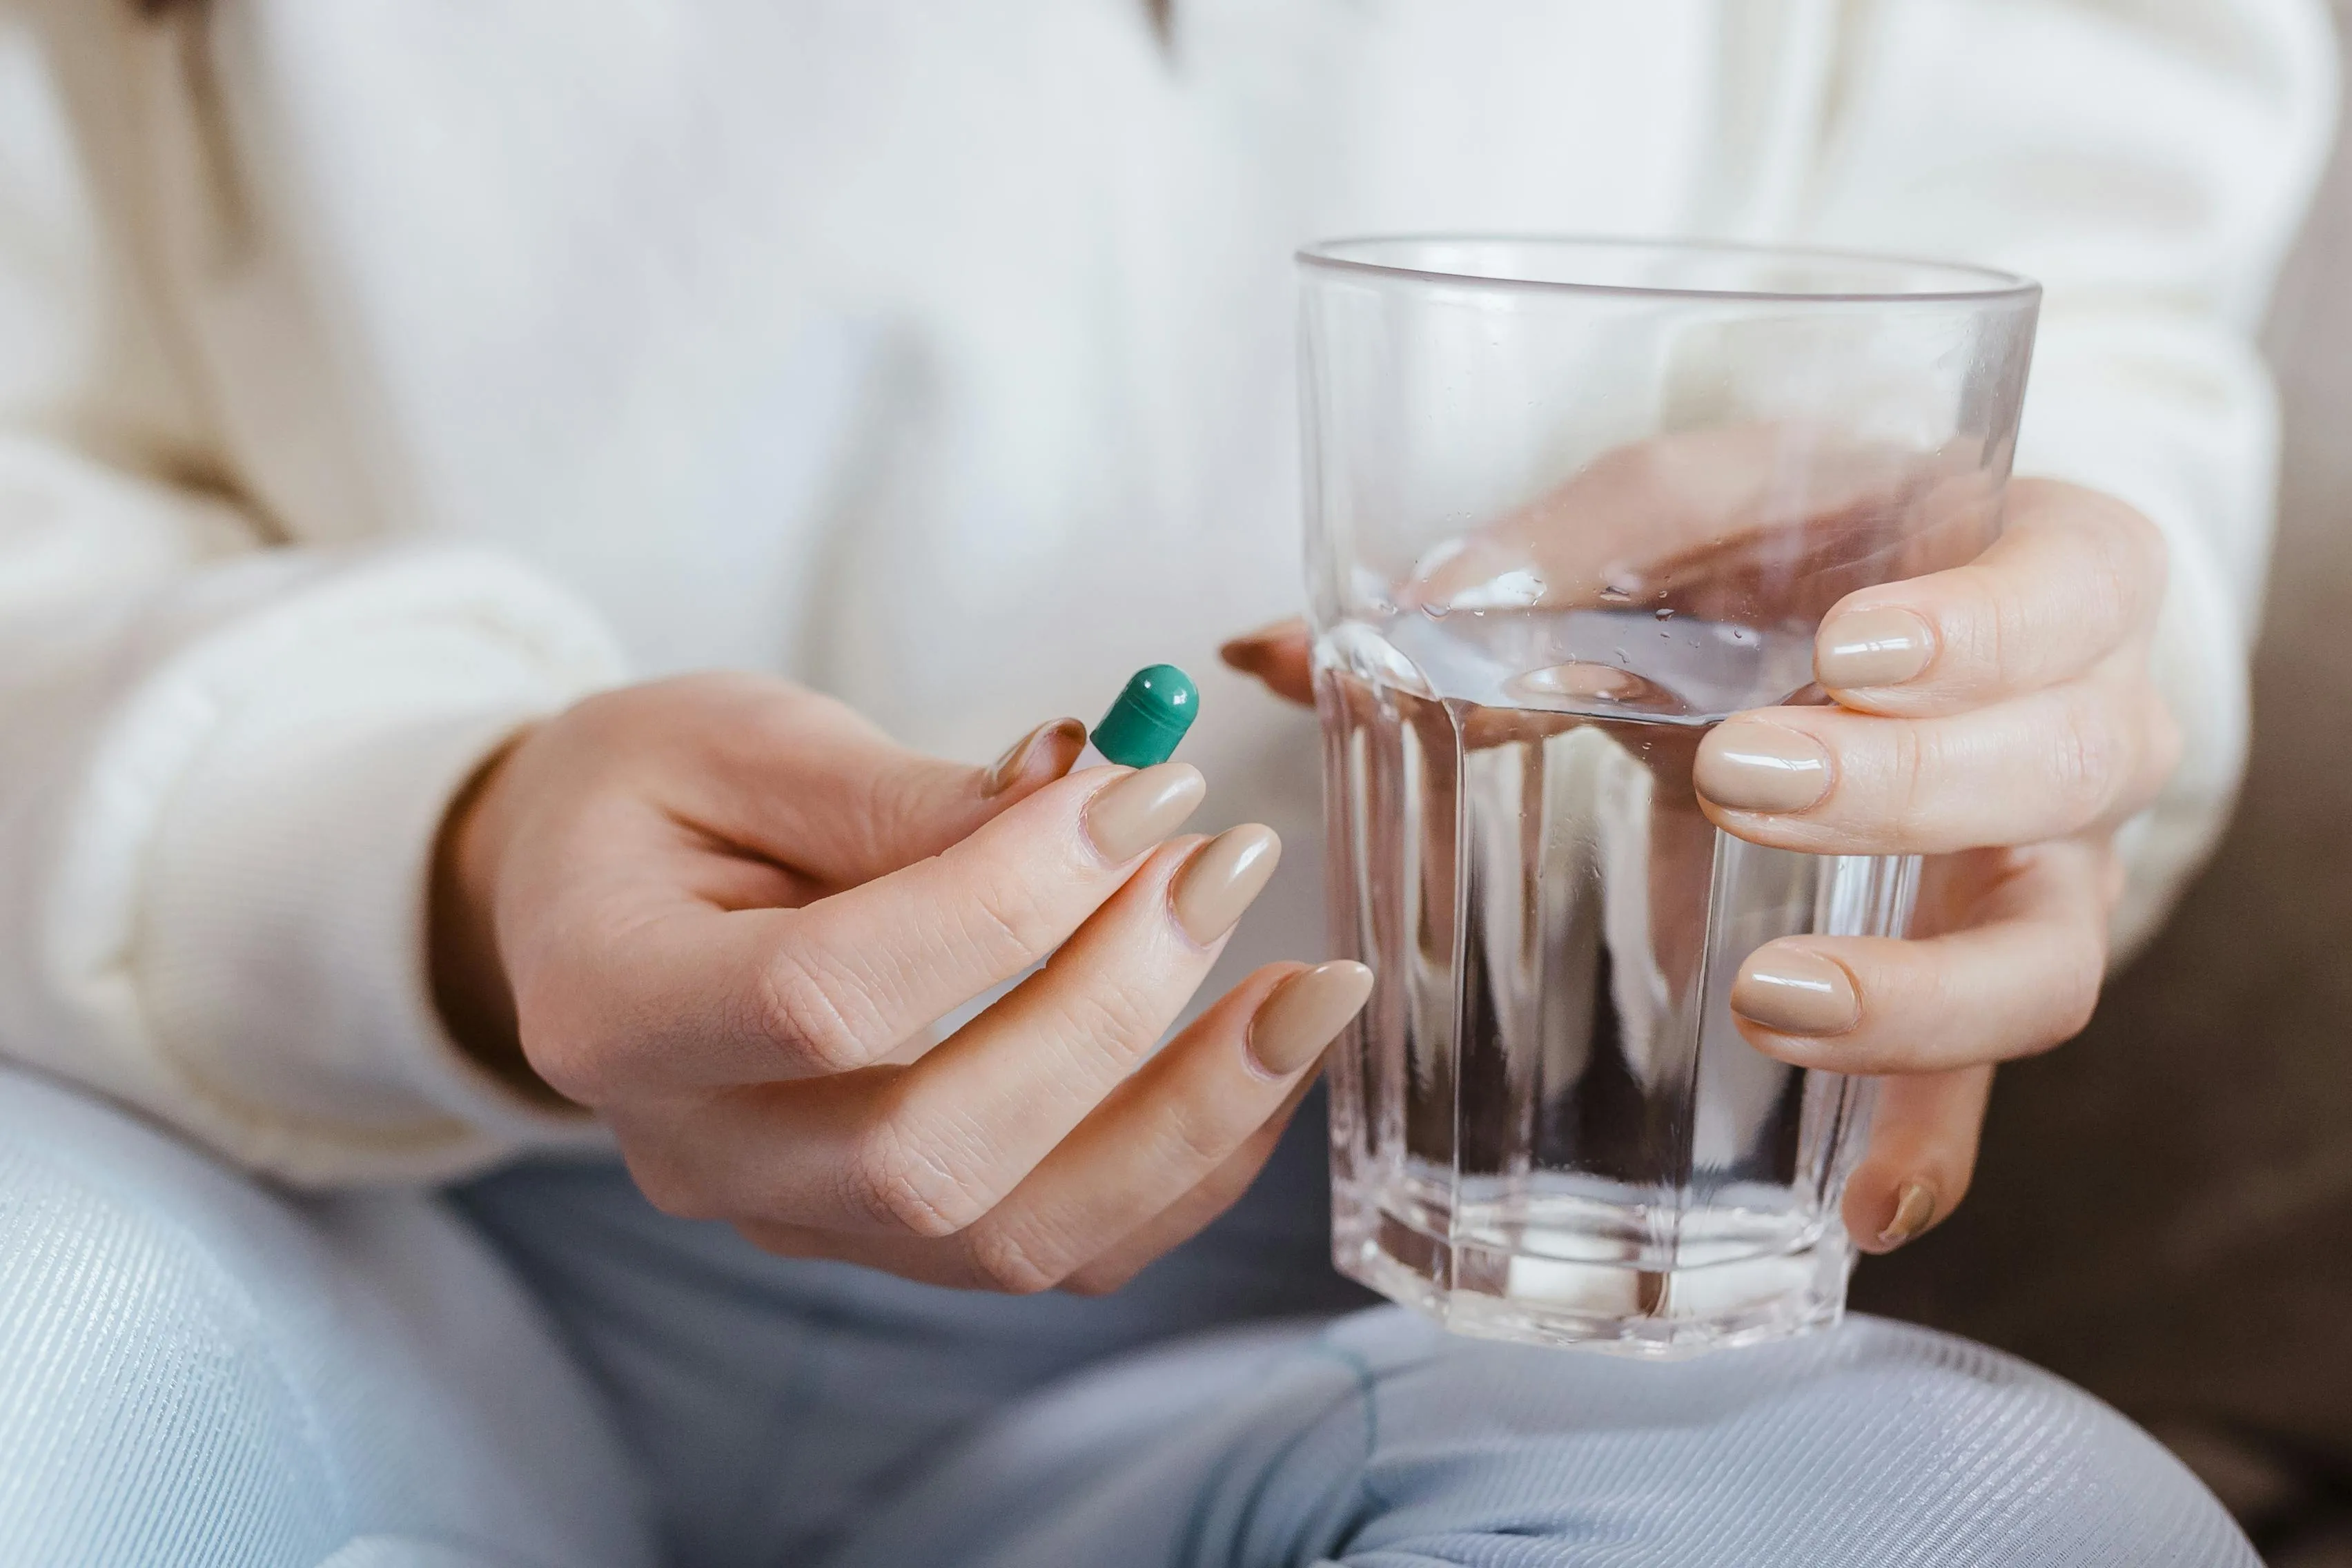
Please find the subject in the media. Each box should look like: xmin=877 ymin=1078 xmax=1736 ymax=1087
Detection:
xmin=0 ymin=1072 xmax=2253 ymax=1568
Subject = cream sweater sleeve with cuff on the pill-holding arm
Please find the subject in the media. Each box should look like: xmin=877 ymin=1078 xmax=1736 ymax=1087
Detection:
xmin=0 ymin=7 xmax=618 ymax=1185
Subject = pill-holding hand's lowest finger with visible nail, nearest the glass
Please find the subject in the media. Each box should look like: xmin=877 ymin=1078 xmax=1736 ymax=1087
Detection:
xmin=743 ymin=961 xmax=1371 ymax=1293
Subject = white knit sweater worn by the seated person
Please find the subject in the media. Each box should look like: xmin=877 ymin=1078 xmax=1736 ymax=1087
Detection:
xmin=0 ymin=0 xmax=2333 ymax=1182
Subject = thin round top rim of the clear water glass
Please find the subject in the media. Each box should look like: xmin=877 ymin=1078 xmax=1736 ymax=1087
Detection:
xmin=1293 ymin=231 xmax=2041 ymax=306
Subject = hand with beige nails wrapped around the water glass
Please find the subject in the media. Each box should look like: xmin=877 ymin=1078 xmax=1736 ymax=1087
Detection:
xmin=1226 ymin=480 xmax=2180 ymax=1251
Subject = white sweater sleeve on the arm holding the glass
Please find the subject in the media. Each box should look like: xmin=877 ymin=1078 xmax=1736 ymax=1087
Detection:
xmin=1783 ymin=0 xmax=2335 ymax=952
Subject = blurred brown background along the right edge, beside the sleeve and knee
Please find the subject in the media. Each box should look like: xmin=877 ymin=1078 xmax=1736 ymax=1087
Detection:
xmin=1856 ymin=0 xmax=2352 ymax=1568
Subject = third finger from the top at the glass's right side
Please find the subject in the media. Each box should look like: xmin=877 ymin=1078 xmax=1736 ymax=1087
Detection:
xmin=1731 ymin=844 xmax=2108 ymax=1075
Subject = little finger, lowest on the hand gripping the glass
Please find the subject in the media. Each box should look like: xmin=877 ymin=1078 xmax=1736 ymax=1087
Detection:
xmin=1844 ymin=1067 xmax=1992 ymax=1253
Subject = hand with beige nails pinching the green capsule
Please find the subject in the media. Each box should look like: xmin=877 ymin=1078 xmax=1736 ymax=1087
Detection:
xmin=433 ymin=677 xmax=1371 ymax=1291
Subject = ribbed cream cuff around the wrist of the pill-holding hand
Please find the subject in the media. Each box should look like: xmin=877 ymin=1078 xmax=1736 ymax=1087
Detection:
xmin=101 ymin=555 xmax=618 ymax=1185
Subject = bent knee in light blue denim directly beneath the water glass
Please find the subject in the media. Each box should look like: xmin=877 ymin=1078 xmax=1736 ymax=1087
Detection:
xmin=1228 ymin=1312 xmax=2255 ymax=1568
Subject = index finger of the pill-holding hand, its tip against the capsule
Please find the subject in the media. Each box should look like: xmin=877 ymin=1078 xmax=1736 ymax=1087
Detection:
xmin=524 ymin=764 xmax=1206 ymax=1105
